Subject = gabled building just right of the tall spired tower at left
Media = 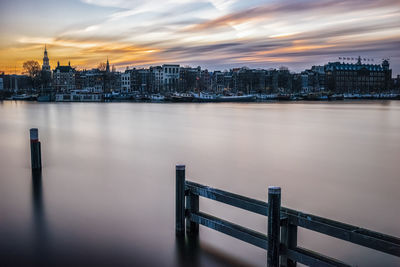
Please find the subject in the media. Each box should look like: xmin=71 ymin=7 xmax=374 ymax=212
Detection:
xmin=53 ymin=62 xmax=76 ymax=92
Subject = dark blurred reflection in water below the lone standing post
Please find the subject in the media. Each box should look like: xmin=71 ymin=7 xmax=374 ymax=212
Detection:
xmin=32 ymin=171 xmax=49 ymax=266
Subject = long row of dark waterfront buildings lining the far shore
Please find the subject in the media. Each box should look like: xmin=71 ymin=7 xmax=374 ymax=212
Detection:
xmin=0 ymin=48 xmax=400 ymax=94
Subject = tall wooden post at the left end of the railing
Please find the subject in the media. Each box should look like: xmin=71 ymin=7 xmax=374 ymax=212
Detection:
xmin=175 ymin=165 xmax=185 ymax=234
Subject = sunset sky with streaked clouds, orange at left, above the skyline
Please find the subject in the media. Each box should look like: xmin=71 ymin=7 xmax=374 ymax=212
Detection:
xmin=0 ymin=0 xmax=400 ymax=75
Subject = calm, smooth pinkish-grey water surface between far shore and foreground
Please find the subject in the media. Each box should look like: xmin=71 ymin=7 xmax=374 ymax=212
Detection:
xmin=0 ymin=101 xmax=400 ymax=266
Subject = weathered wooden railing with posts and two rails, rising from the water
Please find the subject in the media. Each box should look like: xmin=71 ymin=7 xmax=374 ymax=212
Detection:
xmin=176 ymin=165 xmax=400 ymax=266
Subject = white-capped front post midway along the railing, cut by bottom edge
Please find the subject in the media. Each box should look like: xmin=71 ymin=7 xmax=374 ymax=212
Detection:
xmin=267 ymin=186 xmax=281 ymax=267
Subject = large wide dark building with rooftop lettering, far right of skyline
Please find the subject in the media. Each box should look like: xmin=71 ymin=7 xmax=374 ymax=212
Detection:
xmin=325 ymin=57 xmax=392 ymax=93
